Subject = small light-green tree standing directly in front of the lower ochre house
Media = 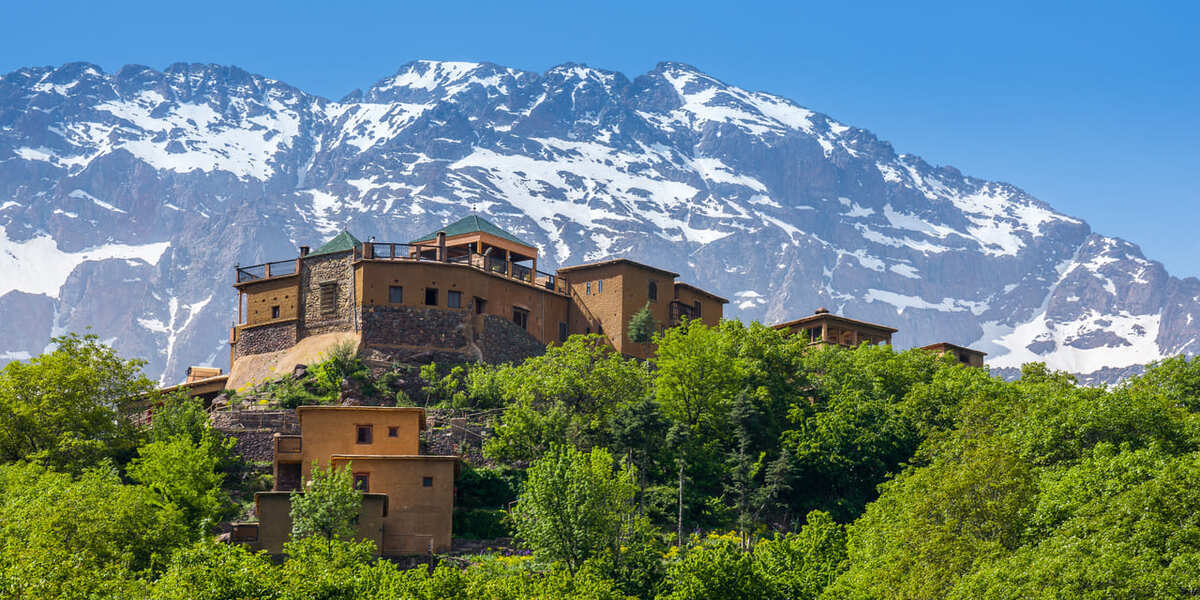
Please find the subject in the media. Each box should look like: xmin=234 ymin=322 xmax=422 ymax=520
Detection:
xmin=292 ymin=462 xmax=362 ymax=541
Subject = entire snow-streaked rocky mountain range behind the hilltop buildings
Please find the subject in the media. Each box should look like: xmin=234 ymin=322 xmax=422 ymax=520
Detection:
xmin=0 ymin=61 xmax=1200 ymax=382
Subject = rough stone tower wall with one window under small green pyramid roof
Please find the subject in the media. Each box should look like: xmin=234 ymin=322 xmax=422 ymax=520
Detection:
xmin=300 ymin=252 xmax=354 ymax=337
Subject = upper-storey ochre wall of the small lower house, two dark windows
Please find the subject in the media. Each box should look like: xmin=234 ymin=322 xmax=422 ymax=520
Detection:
xmin=296 ymin=407 xmax=424 ymax=480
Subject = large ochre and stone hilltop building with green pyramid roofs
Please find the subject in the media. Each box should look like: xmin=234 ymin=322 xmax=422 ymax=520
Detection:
xmin=229 ymin=216 xmax=727 ymax=389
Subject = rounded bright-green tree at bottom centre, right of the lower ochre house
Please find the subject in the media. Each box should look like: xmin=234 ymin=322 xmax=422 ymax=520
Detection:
xmin=512 ymin=446 xmax=637 ymax=574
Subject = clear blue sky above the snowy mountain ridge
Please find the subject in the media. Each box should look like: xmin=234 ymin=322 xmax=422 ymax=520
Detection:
xmin=0 ymin=0 xmax=1200 ymax=276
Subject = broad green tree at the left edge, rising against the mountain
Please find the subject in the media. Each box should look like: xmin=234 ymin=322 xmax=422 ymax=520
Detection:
xmin=0 ymin=334 xmax=154 ymax=473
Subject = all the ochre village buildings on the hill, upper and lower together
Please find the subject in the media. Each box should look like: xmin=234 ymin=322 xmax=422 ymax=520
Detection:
xmin=162 ymin=215 xmax=984 ymax=556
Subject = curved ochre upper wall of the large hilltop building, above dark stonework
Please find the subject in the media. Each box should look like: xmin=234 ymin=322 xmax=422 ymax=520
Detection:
xmin=355 ymin=260 xmax=568 ymax=343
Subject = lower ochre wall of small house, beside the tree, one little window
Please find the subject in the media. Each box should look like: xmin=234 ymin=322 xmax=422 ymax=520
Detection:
xmin=334 ymin=456 xmax=457 ymax=554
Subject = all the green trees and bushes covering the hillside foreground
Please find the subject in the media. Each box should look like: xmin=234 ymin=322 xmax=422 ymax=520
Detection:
xmin=0 ymin=322 xmax=1200 ymax=600
